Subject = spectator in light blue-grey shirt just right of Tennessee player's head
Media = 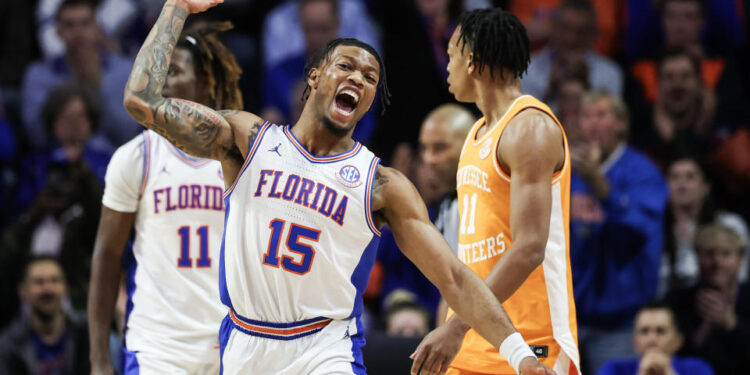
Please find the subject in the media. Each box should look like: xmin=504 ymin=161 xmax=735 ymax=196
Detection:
xmin=521 ymin=0 xmax=623 ymax=101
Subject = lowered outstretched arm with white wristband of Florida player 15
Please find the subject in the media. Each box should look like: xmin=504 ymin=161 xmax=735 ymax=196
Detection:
xmin=373 ymin=167 xmax=551 ymax=374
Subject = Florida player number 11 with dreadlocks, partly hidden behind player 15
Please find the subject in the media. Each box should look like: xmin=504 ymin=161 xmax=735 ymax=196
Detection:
xmin=88 ymin=22 xmax=242 ymax=375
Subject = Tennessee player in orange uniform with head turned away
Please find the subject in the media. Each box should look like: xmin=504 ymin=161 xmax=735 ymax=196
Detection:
xmin=412 ymin=9 xmax=579 ymax=374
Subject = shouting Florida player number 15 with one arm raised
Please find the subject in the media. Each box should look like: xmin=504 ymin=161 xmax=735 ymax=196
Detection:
xmin=125 ymin=0 xmax=551 ymax=374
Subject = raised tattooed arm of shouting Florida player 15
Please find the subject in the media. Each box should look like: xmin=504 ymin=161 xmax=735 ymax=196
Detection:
xmin=124 ymin=0 xmax=262 ymax=164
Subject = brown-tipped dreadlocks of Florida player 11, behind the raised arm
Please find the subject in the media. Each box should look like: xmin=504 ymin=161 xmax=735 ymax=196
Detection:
xmin=176 ymin=21 xmax=243 ymax=109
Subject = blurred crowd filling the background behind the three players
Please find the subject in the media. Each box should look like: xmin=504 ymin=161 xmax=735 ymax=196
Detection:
xmin=0 ymin=0 xmax=750 ymax=374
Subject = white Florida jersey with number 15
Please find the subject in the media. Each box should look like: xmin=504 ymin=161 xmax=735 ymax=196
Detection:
xmin=219 ymin=123 xmax=380 ymax=323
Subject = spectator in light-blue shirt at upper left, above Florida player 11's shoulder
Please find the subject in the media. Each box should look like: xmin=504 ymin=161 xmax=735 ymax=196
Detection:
xmin=21 ymin=0 xmax=140 ymax=150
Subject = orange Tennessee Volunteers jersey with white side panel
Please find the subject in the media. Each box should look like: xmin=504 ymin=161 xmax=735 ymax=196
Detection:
xmin=448 ymin=95 xmax=579 ymax=375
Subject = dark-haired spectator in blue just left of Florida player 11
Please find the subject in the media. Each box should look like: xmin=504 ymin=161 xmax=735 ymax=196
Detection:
xmin=0 ymin=84 xmax=104 ymax=321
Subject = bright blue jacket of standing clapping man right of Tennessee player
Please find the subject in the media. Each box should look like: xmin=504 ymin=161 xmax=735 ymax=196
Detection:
xmin=570 ymin=145 xmax=668 ymax=328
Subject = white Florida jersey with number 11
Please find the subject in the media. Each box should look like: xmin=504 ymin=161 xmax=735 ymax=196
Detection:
xmin=102 ymin=131 xmax=226 ymax=361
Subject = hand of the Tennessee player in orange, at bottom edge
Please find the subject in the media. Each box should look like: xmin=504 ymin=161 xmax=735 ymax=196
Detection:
xmin=409 ymin=324 xmax=466 ymax=375
